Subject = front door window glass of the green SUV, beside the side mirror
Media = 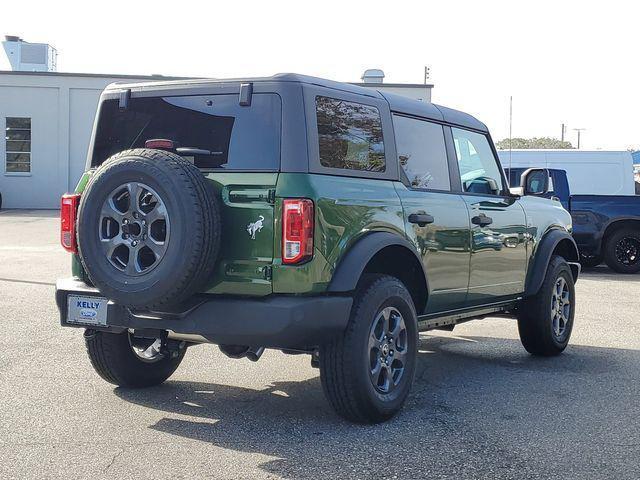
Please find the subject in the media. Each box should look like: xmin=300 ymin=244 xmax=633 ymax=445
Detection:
xmin=451 ymin=128 xmax=502 ymax=195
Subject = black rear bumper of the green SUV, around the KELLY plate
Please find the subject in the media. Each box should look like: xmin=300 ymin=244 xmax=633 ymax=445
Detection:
xmin=56 ymin=278 xmax=353 ymax=348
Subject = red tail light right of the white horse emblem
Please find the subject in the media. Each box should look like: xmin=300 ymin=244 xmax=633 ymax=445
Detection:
xmin=282 ymin=198 xmax=313 ymax=264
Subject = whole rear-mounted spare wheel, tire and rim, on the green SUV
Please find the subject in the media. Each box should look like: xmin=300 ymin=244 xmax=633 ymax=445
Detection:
xmin=77 ymin=149 xmax=222 ymax=310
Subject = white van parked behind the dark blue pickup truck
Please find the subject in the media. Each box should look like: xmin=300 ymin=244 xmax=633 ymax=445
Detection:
xmin=498 ymin=150 xmax=636 ymax=195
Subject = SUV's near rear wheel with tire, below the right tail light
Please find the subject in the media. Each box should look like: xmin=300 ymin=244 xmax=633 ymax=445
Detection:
xmin=320 ymin=275 xmax=418 ymax=423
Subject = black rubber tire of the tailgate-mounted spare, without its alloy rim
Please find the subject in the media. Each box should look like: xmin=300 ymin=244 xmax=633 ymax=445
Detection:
xmin=78 ymin=149 xmax=222 ymax=310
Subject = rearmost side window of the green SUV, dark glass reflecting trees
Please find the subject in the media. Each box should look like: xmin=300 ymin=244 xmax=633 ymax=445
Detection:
xmin=316 ymin=97 xmax=385 ymax=172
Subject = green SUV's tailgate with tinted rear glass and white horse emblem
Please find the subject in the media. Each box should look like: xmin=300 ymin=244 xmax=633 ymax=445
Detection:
xmin=92 ymin=91 xmax=282 ymax=295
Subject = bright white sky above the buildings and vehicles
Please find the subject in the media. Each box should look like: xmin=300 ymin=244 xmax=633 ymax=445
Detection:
xmin=0 ymin=0 xmax=640 ymax=149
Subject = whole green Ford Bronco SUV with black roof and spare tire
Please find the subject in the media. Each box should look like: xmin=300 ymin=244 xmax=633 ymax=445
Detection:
xmin=56 ymin=74 xmax=580 ymax=422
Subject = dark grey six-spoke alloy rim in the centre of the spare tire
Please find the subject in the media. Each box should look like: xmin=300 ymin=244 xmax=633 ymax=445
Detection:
xmin=100 ymin=182 xmax=171 ymax=276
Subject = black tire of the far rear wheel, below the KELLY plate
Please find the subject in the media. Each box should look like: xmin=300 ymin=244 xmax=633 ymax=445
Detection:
xmin=84 ymin=330 xmax=186 ymax=388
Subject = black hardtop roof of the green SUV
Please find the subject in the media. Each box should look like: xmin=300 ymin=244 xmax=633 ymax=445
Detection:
xmin=107 ymin=73 xmax=488 ymax=132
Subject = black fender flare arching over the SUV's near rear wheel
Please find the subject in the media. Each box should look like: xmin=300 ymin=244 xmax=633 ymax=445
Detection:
xmin=328 ymin=232 xmax=429 ymax=295
